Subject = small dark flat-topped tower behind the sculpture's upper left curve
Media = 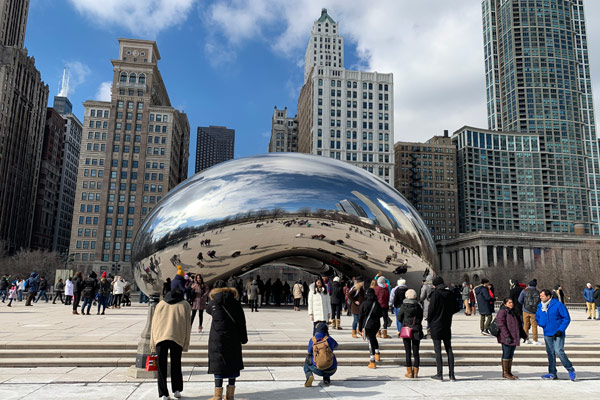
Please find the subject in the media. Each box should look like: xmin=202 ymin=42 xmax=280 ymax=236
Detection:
xmin=195 ymin=125 xmax=235 ymax=173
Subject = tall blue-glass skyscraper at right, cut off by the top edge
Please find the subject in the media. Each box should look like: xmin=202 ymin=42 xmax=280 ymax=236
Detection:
xmin=480 ymin=0 xmax=600 ymax=234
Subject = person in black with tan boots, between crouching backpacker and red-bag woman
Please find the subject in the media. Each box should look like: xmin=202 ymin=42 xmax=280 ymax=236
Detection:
xmin=358 ymin=288 xmax=383 ymax=368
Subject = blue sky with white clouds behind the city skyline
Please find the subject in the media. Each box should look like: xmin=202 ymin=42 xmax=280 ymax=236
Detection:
xmin=25 ymin=0 xmax=600 ymax=175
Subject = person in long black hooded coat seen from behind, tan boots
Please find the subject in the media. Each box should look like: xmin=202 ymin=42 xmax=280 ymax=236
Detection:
xmin=206 ymin=281 xmax=248 ymax=400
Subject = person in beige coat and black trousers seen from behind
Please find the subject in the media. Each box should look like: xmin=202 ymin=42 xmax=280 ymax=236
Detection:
xmin=150 ymin=288 xmax=192 ymax=400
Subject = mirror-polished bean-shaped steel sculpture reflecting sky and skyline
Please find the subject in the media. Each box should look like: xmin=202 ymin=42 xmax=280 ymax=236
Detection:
xmin=133 ymin=153 xmax=437 ymax=294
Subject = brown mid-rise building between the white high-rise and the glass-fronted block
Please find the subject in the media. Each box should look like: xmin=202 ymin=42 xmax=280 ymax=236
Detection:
xmin=394 ymin=131 xmax=458 ymax=241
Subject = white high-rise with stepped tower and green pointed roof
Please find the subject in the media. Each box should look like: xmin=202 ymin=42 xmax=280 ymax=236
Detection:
xmin=298 ymin=9 xmax=394 ymax=184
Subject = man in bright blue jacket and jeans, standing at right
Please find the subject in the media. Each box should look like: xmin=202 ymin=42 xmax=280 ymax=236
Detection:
xmin=535 ymin=289 xmax=576 ymax=381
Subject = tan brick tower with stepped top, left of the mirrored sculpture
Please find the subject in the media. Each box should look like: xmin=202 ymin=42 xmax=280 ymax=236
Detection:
xmin=69 ymin=39 xmax=190 ymax=279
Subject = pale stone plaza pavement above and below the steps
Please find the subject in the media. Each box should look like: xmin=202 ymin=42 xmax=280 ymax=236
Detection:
xmin=0 ymin=303 xmax=600 ymax=400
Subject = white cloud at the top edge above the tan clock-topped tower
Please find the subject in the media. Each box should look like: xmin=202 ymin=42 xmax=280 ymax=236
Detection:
xmin=69 ymin=0 xmax=196 ymax=38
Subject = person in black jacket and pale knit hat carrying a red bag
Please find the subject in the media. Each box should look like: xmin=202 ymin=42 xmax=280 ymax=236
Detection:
xmin=397 ymin=289 xmax=423 ymax=379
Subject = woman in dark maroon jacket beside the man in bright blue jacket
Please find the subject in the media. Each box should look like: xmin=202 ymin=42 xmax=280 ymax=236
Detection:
xmin=496 ymin=298 xmax=527 ymax=380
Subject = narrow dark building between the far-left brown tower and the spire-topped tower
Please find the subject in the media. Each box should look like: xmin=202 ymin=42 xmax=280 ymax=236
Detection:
xmin=31 ymin=108 xmax=65 ymax=250
